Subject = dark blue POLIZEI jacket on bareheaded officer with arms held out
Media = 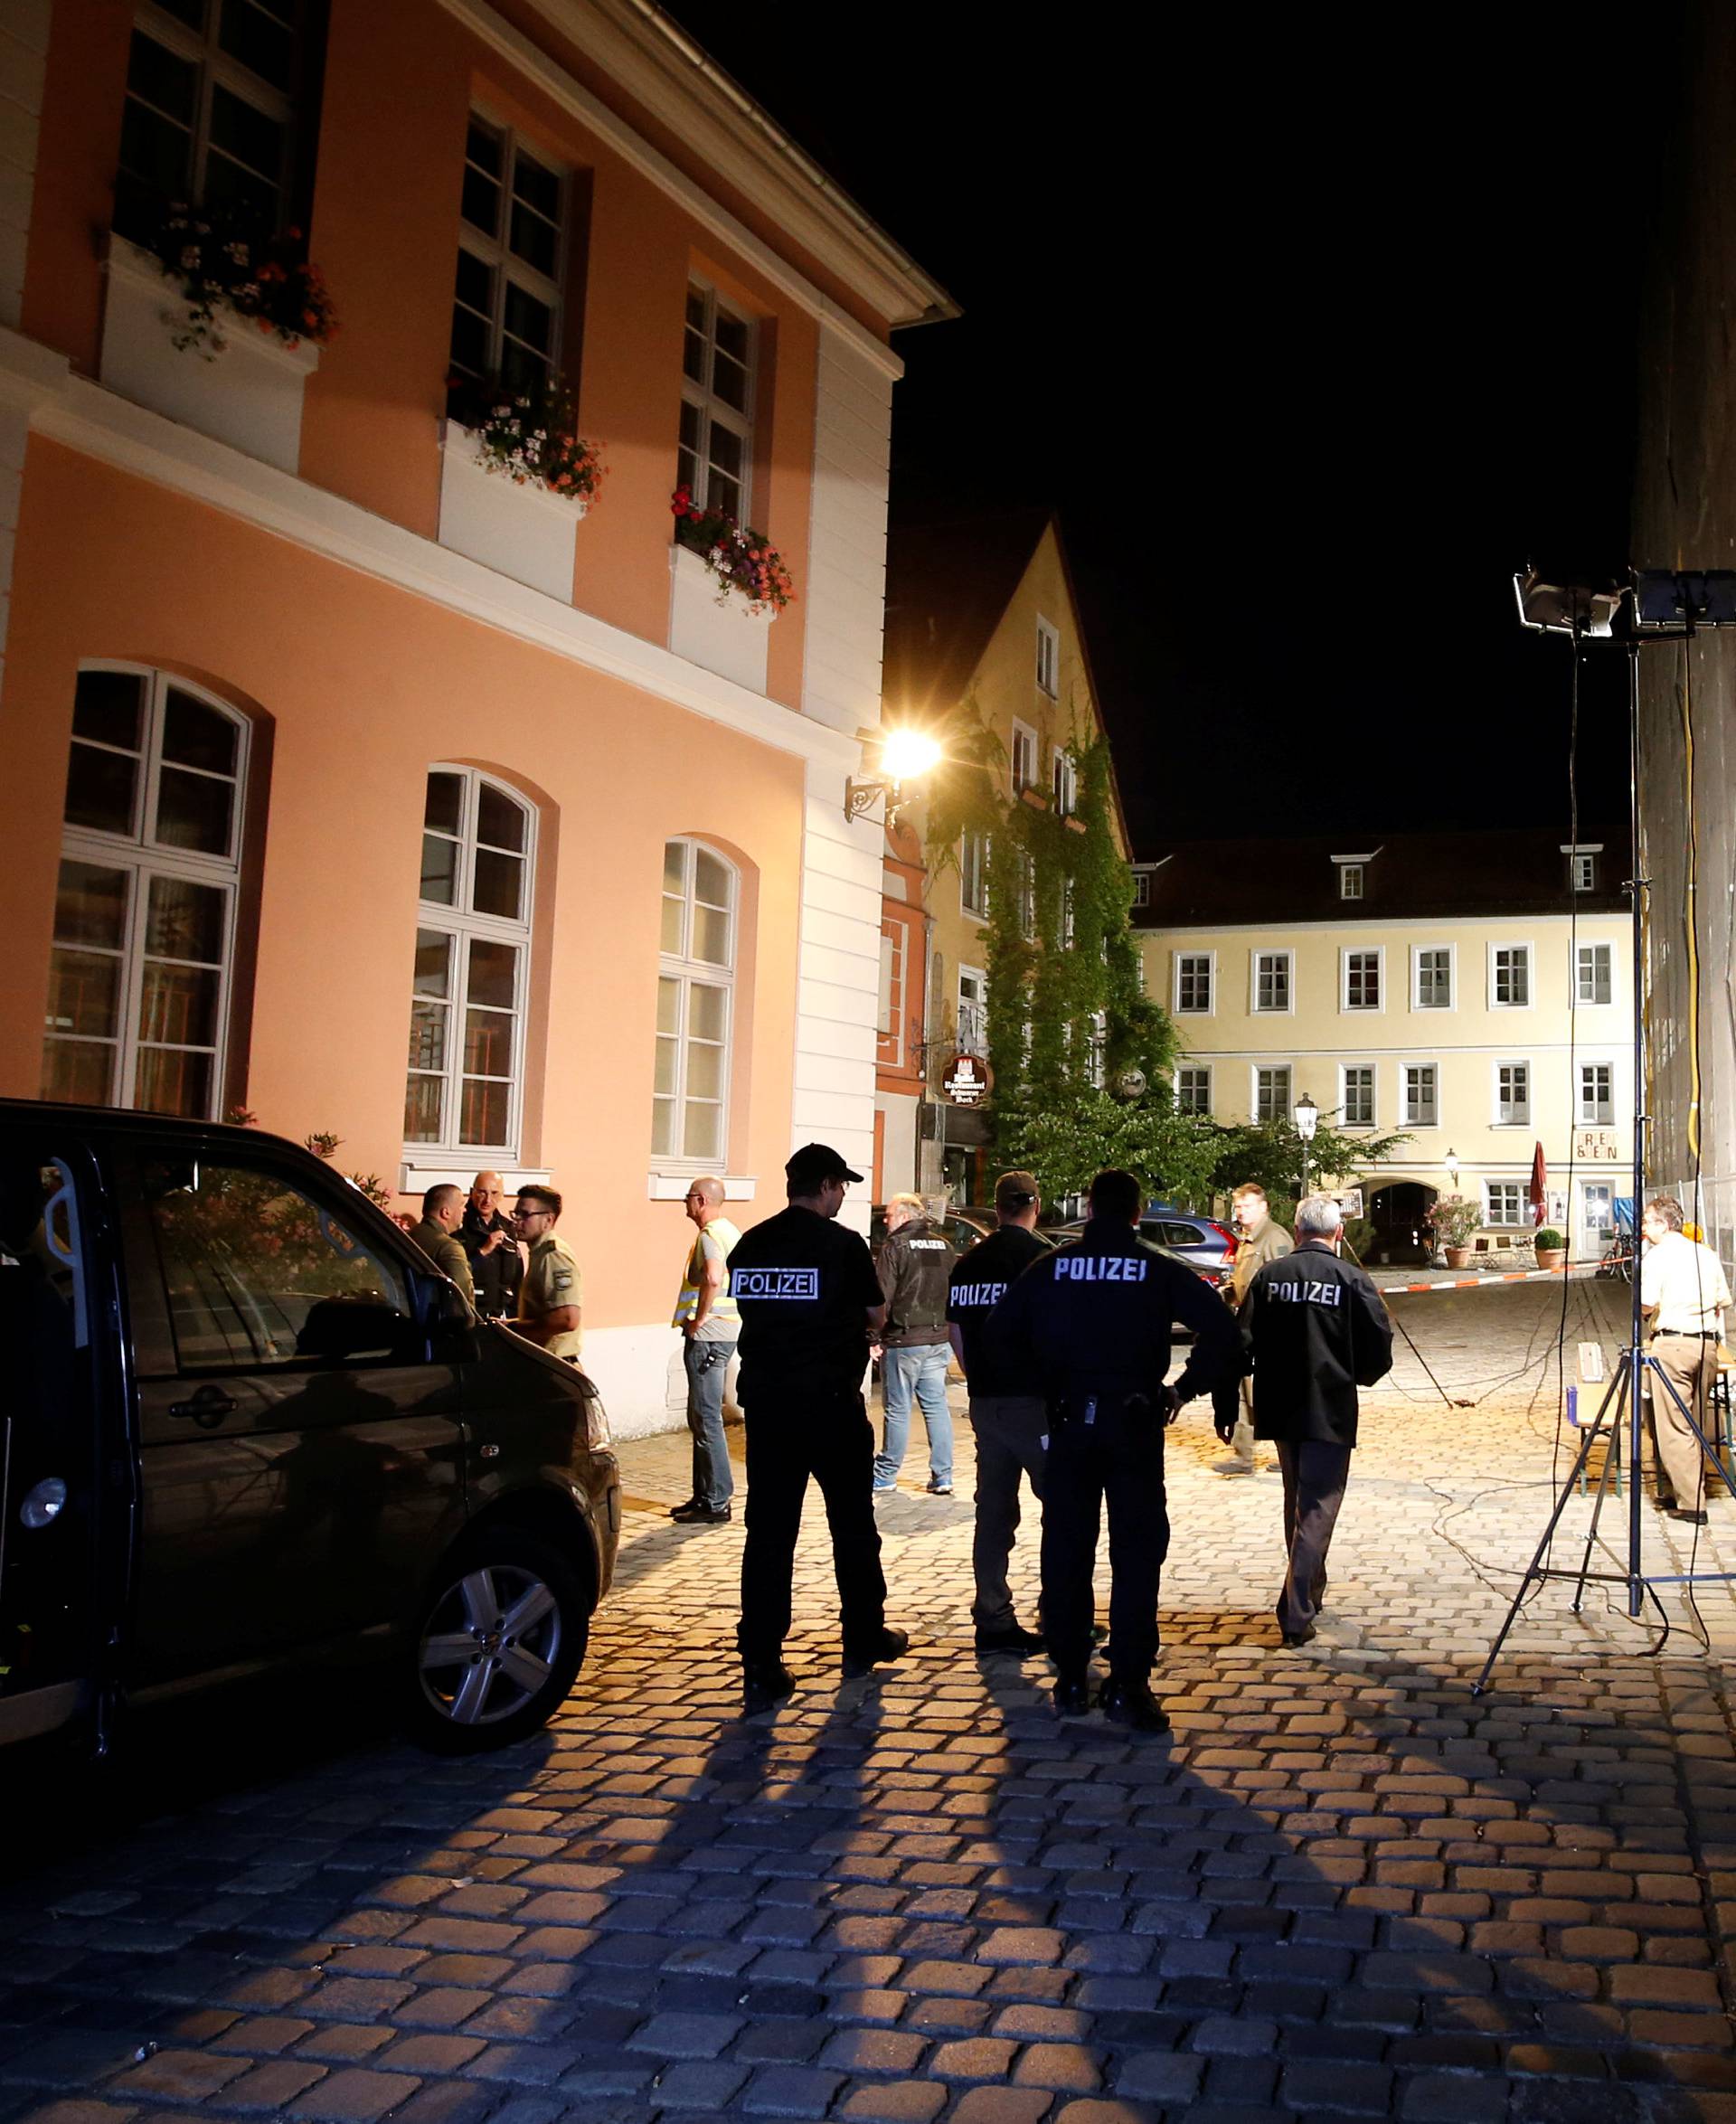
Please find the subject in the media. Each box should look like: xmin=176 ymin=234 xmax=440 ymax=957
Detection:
xmin=992 ymin=1217 xmax=1241 ymax=1402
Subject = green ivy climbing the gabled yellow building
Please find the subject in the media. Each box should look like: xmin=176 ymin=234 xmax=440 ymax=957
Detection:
xmin=927 ymin=703 xmax=1164 ymax=1198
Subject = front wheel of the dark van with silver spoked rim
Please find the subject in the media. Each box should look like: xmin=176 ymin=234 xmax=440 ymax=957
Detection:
xmin=406 ymin=1527 xmax=590 ymax=1754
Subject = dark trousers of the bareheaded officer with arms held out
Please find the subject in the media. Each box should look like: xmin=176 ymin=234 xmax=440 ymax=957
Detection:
xmin=1043 ymin=1404 xmax=1169 ymax=1682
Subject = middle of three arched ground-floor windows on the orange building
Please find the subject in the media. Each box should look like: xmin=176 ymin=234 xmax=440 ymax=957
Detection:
xmin=404 ymin=767 xmax=535 ymax=1157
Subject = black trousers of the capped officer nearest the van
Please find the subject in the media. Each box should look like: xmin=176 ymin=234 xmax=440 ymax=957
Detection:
xmin=735 ymin=1393 xmax=886 ymax=1663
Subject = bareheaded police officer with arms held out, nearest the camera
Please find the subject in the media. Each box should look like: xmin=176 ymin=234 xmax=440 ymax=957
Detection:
xmin=995 ymin=1170 xmax=1241 ymax=1733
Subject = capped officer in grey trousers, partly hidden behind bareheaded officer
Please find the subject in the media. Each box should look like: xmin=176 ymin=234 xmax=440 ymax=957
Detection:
xmin=946 ymin=1173 xmax=1050 ymax=1655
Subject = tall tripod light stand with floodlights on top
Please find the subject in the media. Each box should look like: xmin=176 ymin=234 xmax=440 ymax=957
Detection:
xmin=1473 ymin=573 xmax=1736 ymax=1695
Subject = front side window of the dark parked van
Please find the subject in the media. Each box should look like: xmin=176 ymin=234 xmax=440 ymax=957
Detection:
xmin=142 ymin=1157 xmax=410 ymax=1372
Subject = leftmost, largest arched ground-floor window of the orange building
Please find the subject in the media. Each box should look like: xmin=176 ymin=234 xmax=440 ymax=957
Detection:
xmin=42 ymin=665 xmax=247 ymax=1119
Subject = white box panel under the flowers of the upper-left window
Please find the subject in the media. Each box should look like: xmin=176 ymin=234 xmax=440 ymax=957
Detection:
xmin=98 ymin=236 xmax=319 ymax=471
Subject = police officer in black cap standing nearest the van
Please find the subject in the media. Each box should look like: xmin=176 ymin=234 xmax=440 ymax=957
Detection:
xmin=729 ymin=1143 xmax=910 ymax=1714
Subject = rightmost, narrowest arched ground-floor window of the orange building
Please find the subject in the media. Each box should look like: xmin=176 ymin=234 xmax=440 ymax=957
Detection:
xmin=650 ymin=841 xmax=737 ymax=1166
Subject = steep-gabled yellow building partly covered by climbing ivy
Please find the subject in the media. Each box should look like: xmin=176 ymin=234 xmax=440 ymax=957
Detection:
xmin=875 ymin=512 xmax=1128 ymax=1203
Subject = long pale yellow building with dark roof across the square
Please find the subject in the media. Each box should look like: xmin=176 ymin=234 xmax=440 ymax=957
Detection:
xmin=1135 ymin=830 xmax=1634 ymax=1261
